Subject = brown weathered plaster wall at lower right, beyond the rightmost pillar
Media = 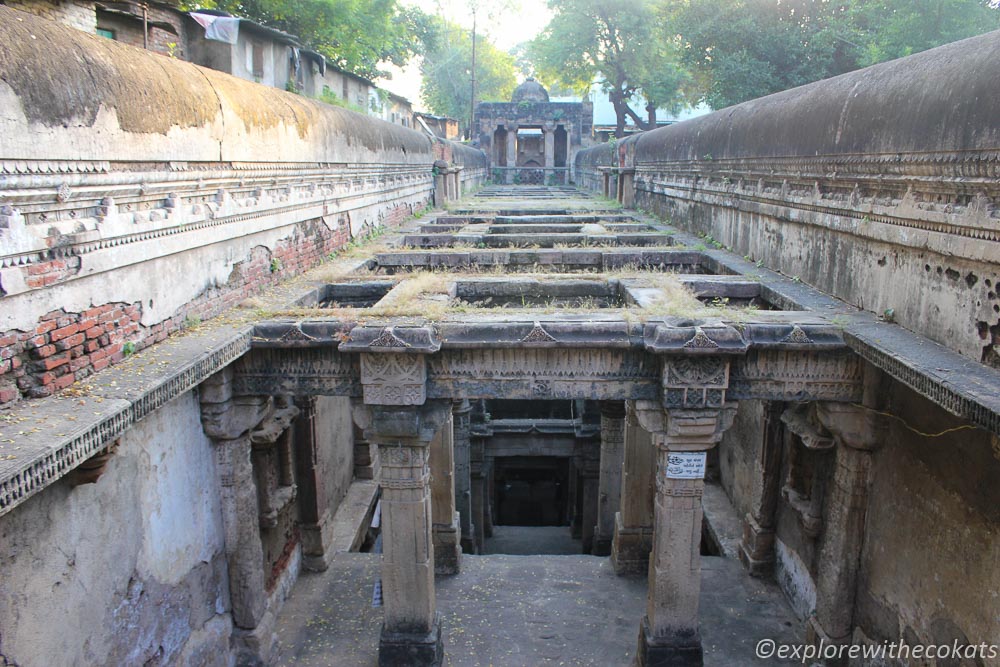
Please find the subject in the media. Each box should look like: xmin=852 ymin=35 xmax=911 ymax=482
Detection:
xmin=855 ymin=384 xmax=1000 ymax=660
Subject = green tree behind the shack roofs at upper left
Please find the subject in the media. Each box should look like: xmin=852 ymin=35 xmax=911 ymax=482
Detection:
xmin=193 ymin=0 xmax=435 ymax=79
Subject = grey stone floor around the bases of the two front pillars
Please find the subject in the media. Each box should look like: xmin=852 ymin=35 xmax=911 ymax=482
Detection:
xmin=276 ymin=553 xmax=800 ymax=667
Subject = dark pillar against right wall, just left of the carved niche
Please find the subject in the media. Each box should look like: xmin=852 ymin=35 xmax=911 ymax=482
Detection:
xmin=740 ymin=401 xmax=785 ymax=577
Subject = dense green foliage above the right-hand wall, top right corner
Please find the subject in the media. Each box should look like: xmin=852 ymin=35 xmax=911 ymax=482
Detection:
xmin=660 ymin=0 xmax=1000 ymax=109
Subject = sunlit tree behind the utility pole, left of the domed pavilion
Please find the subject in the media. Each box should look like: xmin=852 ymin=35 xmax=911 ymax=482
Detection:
xmin=420 ymin=19 xmax=517 ymax=136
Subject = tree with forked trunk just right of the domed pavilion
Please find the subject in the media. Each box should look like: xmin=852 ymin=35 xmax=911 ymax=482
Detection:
xmin=530 ymin=0 xmax=686 ymax=137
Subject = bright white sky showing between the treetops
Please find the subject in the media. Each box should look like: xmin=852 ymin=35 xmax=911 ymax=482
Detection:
xmin=377 ymin=0 xmax=551 ymax=110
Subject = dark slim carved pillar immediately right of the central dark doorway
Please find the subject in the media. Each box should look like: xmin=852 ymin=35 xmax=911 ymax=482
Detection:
xmin=592 ymin=401 xmax=625 ymax=556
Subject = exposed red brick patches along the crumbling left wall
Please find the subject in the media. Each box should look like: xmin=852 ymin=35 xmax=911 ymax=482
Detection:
xmin=0 ymin=211 xmax=412 ymax=405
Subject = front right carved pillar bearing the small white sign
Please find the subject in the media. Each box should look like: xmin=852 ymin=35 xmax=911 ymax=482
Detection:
xmin=636 ymin=408 xmax=735 ymax=666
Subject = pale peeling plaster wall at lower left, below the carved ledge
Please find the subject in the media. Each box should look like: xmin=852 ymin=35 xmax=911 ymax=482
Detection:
xmin=0 ymin=392 xmax=231 ymax=665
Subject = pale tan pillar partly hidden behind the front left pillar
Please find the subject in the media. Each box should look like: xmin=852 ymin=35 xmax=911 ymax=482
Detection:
xmin=430 ymin=412 xmax=462 ymax=574
